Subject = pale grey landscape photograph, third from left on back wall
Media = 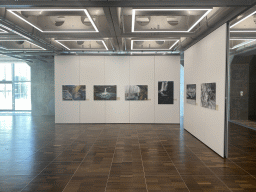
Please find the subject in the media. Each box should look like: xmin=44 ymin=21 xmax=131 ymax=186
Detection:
xmin=125 ymin=85 xmax=148 ymax=100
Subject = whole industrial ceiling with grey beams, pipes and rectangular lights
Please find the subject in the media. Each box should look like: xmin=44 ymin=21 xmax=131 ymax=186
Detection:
xmin=0 ymin=0 xmax=256 ymax=62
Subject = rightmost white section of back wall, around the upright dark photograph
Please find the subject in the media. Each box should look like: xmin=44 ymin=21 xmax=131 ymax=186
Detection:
xmin=155 ymin=56 xmax=180 ymax=123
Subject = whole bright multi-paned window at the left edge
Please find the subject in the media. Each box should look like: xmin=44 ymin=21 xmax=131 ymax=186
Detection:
xmin=0 ymin=63 xmax=31 ymax=110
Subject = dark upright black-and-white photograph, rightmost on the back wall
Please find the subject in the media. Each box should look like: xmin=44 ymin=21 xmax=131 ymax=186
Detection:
xmin=158 ymin=81 xmax=174 ymax=104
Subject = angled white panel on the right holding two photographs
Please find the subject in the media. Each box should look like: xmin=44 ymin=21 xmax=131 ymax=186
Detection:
xmin=184 ymin=24 xmax=227 ymax=157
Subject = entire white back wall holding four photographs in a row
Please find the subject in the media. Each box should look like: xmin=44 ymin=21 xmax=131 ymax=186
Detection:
xmin=55 ymin=56 xmax=180 ymax=123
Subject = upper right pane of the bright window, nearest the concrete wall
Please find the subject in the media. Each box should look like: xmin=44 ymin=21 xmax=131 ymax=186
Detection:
xmin=14 ymin=63 xmax=31 ymax=81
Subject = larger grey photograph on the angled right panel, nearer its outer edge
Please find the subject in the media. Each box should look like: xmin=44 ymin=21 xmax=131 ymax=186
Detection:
xmin=201 ymin=83 xmax=216 ymax=110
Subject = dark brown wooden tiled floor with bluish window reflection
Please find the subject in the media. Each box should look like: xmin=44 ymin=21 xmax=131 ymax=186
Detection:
xmin=0 ymin=116 xmax=256 ymax=192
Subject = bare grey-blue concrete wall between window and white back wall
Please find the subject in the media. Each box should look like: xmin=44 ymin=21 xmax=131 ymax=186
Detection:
xmin=29 ymin=62 xmax=55 ymax=116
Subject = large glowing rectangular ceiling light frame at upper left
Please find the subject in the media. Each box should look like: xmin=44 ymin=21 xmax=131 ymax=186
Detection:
xmin=8 ymin=9 xmax=99 ymax=33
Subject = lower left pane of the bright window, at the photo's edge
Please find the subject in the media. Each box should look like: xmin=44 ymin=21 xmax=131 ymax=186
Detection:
xmin=0 ymin=84 xmax=12 ymax=110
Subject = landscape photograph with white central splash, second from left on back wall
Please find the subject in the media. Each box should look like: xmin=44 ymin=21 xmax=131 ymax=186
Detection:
xmin=94 ymin=85 xmax=116 ymax=100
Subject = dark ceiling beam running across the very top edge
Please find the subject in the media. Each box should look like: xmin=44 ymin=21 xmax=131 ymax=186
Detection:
xmin=0 ymin=0 xmax=254 ymax=8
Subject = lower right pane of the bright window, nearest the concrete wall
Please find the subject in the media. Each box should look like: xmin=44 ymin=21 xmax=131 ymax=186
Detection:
xmin=15 ymin=82 xmax=31 ymax=110
